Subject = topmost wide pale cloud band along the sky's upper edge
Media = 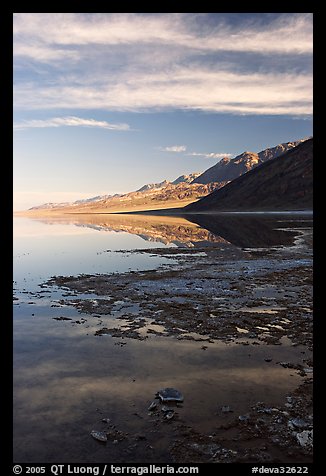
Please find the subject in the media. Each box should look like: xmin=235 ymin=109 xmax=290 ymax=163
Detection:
xmin=14 ymin=13 xmax=312 ymax=54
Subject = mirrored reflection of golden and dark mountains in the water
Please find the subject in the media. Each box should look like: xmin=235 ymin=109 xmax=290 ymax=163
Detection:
xmin=26 ymin=214 xmax=312 ymax=248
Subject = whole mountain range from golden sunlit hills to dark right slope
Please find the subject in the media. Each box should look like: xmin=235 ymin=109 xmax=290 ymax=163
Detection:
xmin=24 ymin=139 xmax=312 ymax=214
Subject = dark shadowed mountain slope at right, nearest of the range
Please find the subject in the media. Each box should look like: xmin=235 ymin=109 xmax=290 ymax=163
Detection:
xmin=184 ymin=139 xmax=313 ymax=213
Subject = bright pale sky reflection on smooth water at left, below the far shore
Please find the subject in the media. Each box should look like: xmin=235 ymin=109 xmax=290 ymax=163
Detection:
xmin=13 ymin=218 xmax=174 ymax=287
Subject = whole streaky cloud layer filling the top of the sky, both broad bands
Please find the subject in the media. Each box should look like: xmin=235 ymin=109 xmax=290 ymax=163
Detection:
xmin=14 ymin=13 xmax=313 ymax=117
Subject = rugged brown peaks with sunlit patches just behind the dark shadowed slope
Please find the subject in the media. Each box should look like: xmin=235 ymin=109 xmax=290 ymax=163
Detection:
xmin=192 ymin=139 xmax=304 ymax=184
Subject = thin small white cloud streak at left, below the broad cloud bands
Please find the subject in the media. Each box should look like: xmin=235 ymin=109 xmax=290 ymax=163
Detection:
xmin=14 ymin=116 xmax=129 ymax=131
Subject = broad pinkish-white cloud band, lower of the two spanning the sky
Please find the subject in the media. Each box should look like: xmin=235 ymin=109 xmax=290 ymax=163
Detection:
xmin=15 ymin=68 xmax=312 ymax=116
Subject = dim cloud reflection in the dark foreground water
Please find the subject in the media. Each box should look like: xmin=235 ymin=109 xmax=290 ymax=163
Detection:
xmin=14 ymin=332 xmax=308 ymax=424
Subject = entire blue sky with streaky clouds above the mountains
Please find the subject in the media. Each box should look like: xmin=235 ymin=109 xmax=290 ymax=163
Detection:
xmin=13 ymin=13 xmax=313 ymax=210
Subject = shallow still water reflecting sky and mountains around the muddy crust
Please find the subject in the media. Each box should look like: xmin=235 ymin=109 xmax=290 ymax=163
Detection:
xmin=14 ymin=217 xmax=309 ymax=463
